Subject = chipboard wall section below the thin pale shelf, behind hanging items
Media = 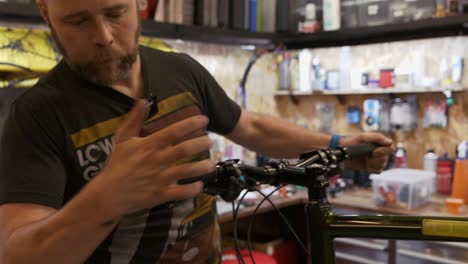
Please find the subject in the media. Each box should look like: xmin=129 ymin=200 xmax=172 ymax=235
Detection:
xmin=277 ymin=92 xmax=468 ymax=168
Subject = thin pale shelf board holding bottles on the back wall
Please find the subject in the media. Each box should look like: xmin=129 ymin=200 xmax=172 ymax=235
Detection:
xmin=275 ymin=87 xmax=468 ymax=96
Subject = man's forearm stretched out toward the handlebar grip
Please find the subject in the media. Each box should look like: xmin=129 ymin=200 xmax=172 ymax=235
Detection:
xmin=228 ymin=112 xmax=331 ymax=158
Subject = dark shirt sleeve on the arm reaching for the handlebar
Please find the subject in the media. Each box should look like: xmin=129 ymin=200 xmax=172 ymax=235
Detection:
xmin=176 ymin=54 xmax=241 ymax=134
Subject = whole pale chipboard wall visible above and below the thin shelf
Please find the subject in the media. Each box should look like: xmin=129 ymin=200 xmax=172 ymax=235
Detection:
xmin=149 ymin=37 xmax=468 ymax=168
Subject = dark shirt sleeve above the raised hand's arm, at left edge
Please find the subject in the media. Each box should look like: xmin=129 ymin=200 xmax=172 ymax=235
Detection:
xmin=0 ymin=95 xmax=66 ymax=209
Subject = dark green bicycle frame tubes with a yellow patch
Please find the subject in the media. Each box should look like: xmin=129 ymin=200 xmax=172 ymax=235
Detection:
xmin=306 ymin=187 xmax=468 ymax=264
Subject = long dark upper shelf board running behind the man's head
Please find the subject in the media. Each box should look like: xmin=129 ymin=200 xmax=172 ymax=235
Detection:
xmin=0 ymin=2 xmax=468 ymax=49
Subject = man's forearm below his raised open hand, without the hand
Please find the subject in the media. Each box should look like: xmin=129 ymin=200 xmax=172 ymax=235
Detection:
xmin=2 ymin=182 xmax=118 ymax=264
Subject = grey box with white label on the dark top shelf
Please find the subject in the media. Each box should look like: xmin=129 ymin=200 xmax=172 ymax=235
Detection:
xmin=358 ymin=0 xmax=391 ymax=27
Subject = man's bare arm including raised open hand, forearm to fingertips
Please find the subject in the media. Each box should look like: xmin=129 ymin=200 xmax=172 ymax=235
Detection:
xmin=0 ymin=100 xmax=209 ymax=264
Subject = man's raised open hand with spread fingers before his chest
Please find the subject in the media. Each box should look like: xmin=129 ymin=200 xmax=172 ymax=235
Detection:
xmin=88 ymin=100 xmax=215 ymax=218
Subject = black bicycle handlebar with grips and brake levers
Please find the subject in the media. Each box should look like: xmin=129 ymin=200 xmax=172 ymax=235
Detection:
xmin=179 ymin=143 xmax=377 ymax=201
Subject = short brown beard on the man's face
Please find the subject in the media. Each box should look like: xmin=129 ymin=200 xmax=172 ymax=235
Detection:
xmin=49 ymin=19 xmax=141 ymax=86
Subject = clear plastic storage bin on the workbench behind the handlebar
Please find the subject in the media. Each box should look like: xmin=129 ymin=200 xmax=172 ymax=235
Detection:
xmin=370 ymin=169 xmax=435 ymax=209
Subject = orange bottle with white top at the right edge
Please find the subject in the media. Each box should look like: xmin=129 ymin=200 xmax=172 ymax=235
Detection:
xmin=452 ymin=141 xmax=468 ymax=204
